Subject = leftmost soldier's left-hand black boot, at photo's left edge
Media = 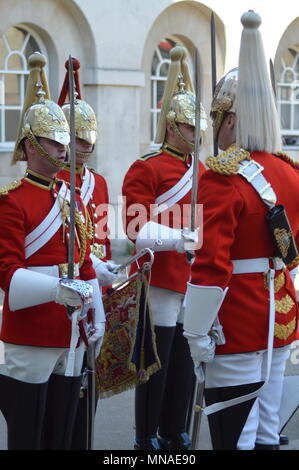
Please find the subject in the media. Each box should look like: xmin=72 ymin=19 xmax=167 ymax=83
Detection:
xmin=0 ymin=375 xmax=48 ymax=450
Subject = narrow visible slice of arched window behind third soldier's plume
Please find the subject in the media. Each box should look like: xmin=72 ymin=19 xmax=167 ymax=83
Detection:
xmin=151 ymin=39 xmax=176 ymax=147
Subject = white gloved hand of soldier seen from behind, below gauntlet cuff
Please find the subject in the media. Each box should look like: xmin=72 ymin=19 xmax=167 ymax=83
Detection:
xmin=184 ymin=331 xmax=216 ymax=367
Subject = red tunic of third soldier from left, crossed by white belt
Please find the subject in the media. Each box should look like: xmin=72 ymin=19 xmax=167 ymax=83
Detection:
xmin=123 ymin=152 xmax=205 ymax=294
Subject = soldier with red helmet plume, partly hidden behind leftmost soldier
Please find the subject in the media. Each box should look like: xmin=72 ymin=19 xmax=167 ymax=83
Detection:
xmin=57 ymin=58 xmax=118 ymax=450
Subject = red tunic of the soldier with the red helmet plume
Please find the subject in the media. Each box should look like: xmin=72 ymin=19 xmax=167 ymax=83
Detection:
xmin=57 ymin=165 xmax=112 ymax=260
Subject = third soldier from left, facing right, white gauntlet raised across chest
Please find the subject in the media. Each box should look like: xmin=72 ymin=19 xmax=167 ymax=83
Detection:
xmin=123 ymin=46 xmax=206 ymax=450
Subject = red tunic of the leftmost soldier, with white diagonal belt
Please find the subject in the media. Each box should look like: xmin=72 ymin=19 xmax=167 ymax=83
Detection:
xmin=0 ymin=179 xmax=96 ymax=348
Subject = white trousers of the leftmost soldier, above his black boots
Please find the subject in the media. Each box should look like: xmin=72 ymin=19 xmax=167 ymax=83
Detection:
xmin=0 ymin=342 xmax=85 ymax=383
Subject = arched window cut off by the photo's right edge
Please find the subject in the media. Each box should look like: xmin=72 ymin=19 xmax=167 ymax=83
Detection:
xmin=278 ymin=46 xmax=299 ymax=147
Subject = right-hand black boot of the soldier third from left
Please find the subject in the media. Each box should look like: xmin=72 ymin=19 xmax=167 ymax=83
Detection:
xmin=158 ymin=323 xmax=194 ymax=450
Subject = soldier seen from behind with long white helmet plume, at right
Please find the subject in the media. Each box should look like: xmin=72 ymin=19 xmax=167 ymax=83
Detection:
xmin=184 ymin=11 xmax=299 ymax=450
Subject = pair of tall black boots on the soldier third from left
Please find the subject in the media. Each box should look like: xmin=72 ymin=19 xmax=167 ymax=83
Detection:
xmin=135 ymin=324 xmax=194 ymax=448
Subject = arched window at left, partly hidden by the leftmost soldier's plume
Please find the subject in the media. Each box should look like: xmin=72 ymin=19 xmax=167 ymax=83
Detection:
xmin=0 ymin=26 xmax=41 ymax=150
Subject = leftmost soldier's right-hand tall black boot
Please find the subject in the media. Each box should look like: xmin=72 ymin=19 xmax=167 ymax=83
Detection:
xmin=43 ymin=374 xmax=82 ymax=450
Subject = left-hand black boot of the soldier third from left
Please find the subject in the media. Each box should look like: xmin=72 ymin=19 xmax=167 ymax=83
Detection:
xmin=134 ymin=326 xmax=176 ymax=450
